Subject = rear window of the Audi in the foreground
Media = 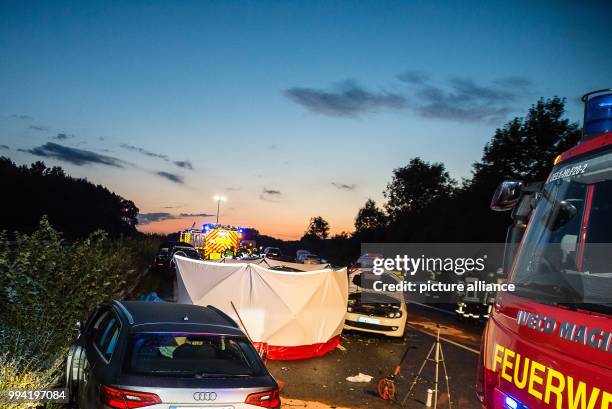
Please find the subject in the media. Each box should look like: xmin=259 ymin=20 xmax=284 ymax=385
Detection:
xmin=124 ymin=333 xmax=265 ymax=378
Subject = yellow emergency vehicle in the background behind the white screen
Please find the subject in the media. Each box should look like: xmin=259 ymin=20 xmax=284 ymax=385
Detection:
xmin=180 ymin=223 xmax=255 ymax=260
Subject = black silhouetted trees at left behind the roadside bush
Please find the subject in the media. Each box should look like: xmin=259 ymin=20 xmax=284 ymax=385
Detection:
xmin=0 ymin=157 xmax=138 ymax=240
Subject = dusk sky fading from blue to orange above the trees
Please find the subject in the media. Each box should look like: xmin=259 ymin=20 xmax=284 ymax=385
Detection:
xmin=0 ymin=1 xmax=612 ymax=239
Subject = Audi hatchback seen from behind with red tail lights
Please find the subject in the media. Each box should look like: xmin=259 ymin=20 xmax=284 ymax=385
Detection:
xmin=66 ymin=301 xmax=281 ymax=409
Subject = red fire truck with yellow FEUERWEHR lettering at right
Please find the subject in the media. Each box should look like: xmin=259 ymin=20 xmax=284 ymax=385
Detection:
xmin=476 ymin=89 xmax=612 ymax=409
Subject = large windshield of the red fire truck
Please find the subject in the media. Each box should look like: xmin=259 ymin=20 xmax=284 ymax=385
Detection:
xmin=511 ymin=152 xmax=612 ymax=314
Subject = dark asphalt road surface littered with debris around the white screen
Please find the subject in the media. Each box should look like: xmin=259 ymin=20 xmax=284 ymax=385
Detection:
xmin=133 ymin=273 xmax=483 ymax=409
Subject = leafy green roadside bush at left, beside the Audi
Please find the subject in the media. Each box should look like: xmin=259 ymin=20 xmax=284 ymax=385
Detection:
xmin=0 ymin=218 xmax=158 ymax=407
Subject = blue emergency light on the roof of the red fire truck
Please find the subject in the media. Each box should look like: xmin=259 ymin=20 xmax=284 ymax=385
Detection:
xmin=582 ymin=88 xmax=612 ymax=139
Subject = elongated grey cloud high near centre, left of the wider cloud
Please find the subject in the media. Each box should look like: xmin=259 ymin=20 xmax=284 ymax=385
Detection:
xmin=284 ymin=81 xmax=406 ymax=117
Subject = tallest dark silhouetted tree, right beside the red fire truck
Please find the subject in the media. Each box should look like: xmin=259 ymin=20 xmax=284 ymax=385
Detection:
xmin=449 ymin=97 xmax=580 ymax=242
